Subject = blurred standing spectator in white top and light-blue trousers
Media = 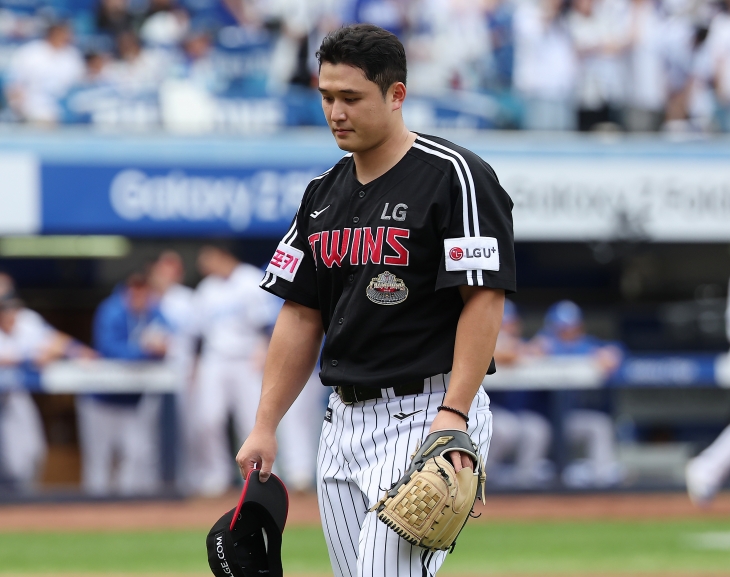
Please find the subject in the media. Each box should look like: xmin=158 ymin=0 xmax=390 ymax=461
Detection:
xmin=514 ymin=0 xmax=577 ymax=130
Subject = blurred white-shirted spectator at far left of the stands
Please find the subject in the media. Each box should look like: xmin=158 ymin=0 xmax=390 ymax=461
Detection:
xmin=5 ymin=22 xmax=84 ymax=124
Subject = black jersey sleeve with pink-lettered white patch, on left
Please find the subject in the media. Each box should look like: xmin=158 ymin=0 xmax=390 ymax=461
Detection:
xmin=259 ymin=184 xmax=320 ymax=309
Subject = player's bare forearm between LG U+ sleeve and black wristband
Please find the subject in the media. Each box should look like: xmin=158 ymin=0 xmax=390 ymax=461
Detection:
xmin=444 ymin=287 xmax=504 ymax=413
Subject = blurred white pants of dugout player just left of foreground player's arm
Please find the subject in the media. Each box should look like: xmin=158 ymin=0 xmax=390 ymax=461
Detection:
xmin=189 ymin=354 xmax=261 ymax=496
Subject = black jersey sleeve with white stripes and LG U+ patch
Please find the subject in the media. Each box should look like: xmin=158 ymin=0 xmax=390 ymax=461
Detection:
xmin=436 ymin=155 xmax=517 ymax=293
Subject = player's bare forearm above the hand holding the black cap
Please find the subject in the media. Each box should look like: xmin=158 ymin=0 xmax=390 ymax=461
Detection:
xmin=256 ymin=301 xmax=323 ymax=431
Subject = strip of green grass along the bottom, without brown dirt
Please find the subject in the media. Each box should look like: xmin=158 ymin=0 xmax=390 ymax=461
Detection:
xmin=0 ymin=520 xmax=730 ymax=576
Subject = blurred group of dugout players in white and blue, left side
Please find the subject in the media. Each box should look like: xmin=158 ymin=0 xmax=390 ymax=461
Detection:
xmin=0 ymin=245 xmax=325 ymax=496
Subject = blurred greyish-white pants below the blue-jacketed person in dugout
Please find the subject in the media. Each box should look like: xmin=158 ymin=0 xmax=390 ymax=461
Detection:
xmin=76 ymin=395 xmax=161 ymax=495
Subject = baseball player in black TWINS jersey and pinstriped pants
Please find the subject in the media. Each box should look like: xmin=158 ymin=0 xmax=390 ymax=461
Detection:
xmin=237 ymin=24 xmax=515 ymax=577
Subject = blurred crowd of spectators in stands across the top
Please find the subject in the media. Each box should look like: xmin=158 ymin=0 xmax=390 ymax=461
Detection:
xmin=0 ymin=0 xmax=730 ymax=132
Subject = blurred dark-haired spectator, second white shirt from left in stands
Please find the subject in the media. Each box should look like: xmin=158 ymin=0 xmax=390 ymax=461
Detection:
xmin=106 ymin=30 xmax=171 ymax=96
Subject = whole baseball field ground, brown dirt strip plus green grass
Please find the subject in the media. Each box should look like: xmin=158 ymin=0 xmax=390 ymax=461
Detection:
xmin=0 ymin=493 xmax=730 ymax=577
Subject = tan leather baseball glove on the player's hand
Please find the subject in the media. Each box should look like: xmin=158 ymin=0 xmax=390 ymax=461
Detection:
xmin=370 ymin=430 xmax=486 ymax=551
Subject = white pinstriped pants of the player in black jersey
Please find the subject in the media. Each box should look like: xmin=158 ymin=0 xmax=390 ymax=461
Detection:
xmin=317 ymin=375 xmax=492 ymax=577
